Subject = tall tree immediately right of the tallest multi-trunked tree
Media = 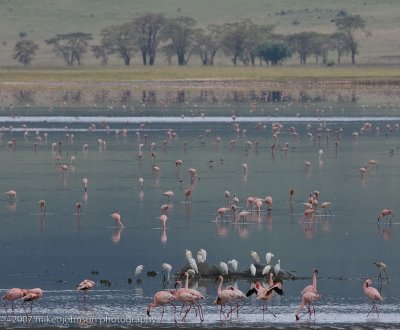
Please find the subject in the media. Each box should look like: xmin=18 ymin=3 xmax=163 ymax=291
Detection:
xmin=163 ymin=16 xmax=197 ymax=65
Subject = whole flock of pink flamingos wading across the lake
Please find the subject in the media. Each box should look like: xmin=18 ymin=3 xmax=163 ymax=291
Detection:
xmin=3 ymin=114 xmax=393 ymax=322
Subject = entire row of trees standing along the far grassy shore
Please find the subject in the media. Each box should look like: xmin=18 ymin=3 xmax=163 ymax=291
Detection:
xmin=13 ymin=11 xmax=369 ymax=66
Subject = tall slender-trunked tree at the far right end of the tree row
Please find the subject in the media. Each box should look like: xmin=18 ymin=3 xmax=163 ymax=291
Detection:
xmin=336 ymin=15 xmax=370 ymax=64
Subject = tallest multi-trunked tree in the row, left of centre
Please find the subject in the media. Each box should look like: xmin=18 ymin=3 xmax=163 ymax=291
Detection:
xmin=132 ymin=13 xmax=166 ymax=65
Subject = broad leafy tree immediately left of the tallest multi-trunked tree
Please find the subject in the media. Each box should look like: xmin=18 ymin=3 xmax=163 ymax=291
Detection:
xmin=100 ymin=23 xmax=137 ymax=65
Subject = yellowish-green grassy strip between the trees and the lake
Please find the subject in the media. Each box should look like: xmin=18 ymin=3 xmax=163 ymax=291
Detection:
xmin=0 ymin=66 xmax=400 ymax=86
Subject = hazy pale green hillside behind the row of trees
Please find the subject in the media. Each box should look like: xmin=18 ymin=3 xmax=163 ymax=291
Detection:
xmin=0 ymin=0 xmax=400 ymax=67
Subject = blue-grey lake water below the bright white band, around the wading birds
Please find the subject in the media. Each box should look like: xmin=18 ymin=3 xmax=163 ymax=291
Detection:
xmin=0 ymin=105 xmax=400 ymax=328
